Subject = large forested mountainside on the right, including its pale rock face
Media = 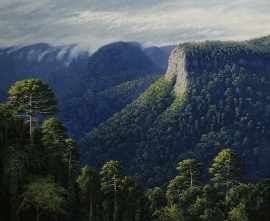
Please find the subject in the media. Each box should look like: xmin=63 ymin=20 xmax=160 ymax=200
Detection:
xmin=80 ymin=37 xmax=270 ymax=186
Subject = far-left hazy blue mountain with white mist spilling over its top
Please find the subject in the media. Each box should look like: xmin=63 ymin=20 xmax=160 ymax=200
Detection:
xmin=0 ymin=43 xmax=89 ymax=97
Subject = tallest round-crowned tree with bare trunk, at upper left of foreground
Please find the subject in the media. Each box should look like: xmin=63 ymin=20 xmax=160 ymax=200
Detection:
xmin=9 ymin=79 xmax=57 ymax=139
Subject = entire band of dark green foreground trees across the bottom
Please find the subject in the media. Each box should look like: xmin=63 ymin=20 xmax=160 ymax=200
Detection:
xmin=0 ymin=79 xmax=270 ymax=221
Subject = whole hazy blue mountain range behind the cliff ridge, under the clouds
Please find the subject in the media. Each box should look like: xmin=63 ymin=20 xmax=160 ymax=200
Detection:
xmin=0 ymin=42 xmax=173 ymax=138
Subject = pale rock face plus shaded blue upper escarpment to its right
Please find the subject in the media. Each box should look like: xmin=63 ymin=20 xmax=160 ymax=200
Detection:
xmin=165 ymin=42 xmax=270 ymax=96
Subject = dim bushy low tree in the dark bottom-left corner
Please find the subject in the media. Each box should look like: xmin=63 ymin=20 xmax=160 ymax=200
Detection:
xmin=17 ymin=178 xmax=66 ymax=221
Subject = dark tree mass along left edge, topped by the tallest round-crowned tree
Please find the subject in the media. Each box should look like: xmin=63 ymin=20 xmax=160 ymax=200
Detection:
xmin=0 ymin=79 xmax=79 ymax=221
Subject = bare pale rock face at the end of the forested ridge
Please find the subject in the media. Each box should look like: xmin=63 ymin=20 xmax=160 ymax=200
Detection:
xmin=165 ymin=47 xmax=188 ymax=96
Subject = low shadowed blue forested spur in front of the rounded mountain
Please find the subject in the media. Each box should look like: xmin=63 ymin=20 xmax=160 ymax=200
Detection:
xmin=63 ymin=74 xmax=160 ymax=138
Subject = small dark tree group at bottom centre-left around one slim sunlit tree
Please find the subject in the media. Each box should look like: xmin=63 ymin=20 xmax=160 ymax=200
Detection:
xmin=77 ymin=161 xmax=150 ymax=221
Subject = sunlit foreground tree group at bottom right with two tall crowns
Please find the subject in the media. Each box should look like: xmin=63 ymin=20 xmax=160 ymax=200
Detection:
xmin=149 ymin=149 xmax=270 ymax=221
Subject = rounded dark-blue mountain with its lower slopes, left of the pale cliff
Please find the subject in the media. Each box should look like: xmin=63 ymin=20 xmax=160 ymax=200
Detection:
xmin=61 ymin=42 xmax=162 ymax=137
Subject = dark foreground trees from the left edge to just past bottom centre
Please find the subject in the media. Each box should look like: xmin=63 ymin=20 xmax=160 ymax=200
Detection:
xmin=0 ymin=79 xmax=156 ymax=221
